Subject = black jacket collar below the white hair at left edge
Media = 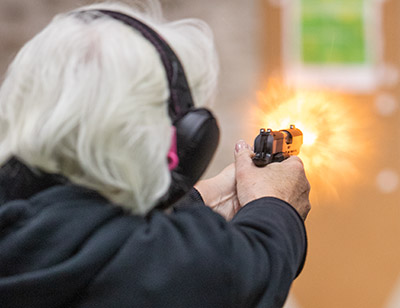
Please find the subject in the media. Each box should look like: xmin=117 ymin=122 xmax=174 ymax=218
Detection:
xmin=0 ymin=157 xmax=68 ymax=205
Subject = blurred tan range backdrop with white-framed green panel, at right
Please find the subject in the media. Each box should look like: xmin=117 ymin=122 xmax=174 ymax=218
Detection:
xmin=261 ymin=0 xmax=400 ymax=308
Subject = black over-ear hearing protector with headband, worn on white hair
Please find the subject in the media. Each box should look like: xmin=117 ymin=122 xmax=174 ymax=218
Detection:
xmin=89 ymin=10 xmax=219 ymax=208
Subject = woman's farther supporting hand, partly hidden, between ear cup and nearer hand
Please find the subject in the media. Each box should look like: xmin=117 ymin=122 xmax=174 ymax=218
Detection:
xmin=195 ymin=164 xmax=240 ymax=220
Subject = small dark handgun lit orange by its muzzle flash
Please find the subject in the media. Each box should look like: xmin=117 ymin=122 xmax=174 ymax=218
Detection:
xmin=253 ymin=125 xmax=303 ymax=167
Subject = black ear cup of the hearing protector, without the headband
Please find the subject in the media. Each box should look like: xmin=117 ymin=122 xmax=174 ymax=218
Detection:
xmin=157 ymin=108 xmax=219 ymax=208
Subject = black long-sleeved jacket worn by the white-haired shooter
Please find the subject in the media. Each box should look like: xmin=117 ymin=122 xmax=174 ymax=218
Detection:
xmin=0 ymin=160 xmax=306 ymax=308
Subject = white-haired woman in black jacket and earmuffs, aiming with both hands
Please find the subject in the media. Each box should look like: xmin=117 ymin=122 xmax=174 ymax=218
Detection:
xmin=0 ymin=2 xmax=310 ymax=308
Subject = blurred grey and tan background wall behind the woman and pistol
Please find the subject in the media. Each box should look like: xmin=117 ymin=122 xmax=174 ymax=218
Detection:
xmin=0 ymin=0 xmax=400 ymax=308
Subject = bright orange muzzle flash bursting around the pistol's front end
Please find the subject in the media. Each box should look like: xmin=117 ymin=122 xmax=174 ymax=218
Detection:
xmin=253 ymin=80 xmax=372 ymax=199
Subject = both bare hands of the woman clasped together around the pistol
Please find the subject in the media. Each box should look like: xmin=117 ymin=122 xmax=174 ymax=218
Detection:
xmin=195 ymin=141 xmax=311 ymax=220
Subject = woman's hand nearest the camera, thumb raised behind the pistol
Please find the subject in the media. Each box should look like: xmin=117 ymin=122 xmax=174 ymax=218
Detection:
xmin=235 ymin=140 xmax=311 ymax=220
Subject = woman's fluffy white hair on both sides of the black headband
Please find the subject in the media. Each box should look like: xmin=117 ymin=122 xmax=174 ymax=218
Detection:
xmin=0 ymin=1 xmax=218 ymax=214
